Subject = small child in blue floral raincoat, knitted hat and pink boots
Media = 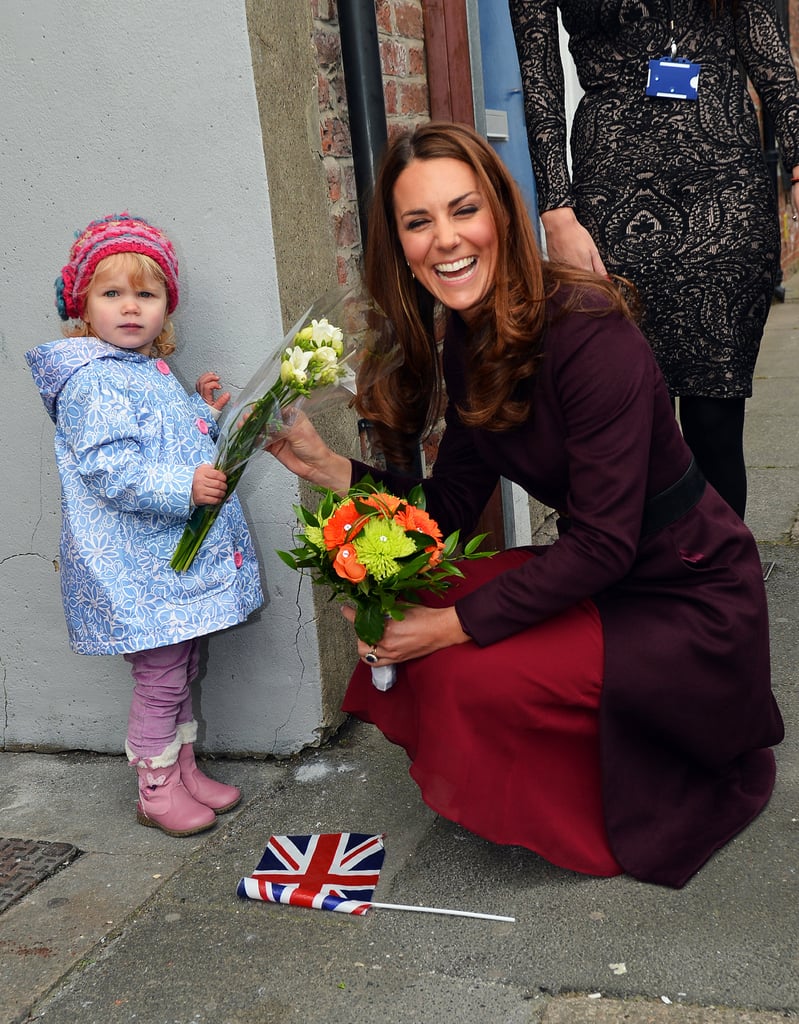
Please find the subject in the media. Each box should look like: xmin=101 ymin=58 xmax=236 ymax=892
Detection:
xmin=26 ymin=213 xmax=263 ymax=836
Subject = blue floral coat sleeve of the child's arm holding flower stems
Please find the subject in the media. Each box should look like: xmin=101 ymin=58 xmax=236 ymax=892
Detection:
xmin=57 ymin=373 xmax=195 ymax=519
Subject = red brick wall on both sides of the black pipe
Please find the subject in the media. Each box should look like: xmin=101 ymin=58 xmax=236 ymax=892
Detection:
xmin=311 ymin=0 xmax=429 ymax=284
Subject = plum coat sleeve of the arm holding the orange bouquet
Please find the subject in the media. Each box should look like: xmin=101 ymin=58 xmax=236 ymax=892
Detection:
xmin=456 ymin=315 xmax=663 ymax=646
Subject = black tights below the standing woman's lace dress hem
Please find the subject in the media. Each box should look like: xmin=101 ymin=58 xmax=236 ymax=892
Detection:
xmin=679 ymin=396 xmax=747 ymax=519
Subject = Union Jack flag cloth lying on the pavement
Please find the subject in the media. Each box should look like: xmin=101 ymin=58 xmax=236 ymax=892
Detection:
xmin=237 ymin=833 xmax=384 ymax=914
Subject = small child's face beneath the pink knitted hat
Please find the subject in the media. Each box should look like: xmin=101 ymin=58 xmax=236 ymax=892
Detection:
xmin=83 ymin=253 xmax=167 ymax=355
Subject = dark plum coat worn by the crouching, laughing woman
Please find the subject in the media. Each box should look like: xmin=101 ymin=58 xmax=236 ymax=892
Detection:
xmin=353 ymin=296 xmax=783 ymax=887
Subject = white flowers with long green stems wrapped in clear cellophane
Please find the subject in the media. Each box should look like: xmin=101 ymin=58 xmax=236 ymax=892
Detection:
xmin=170 ymin=286 xmax=400 ymax=572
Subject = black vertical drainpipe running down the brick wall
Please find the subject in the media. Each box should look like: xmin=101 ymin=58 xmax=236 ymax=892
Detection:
xmin=338 ymin=0 xmax=388 ymax=248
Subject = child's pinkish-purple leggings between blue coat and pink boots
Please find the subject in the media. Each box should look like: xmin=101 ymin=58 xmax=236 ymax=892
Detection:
xmin=123 ymin=639 xmax=200 ymax=759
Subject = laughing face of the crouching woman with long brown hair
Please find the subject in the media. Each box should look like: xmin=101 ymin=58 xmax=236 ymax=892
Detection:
xmin=393 ymin=158 xmax=499 ymax=323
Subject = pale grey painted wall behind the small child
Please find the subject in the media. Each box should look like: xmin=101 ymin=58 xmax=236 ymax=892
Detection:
xmin=0 ymin=0 xmax=320 ymax=754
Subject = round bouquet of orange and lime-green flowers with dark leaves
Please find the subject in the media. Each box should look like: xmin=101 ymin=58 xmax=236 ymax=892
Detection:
xmin=278 ymin=476 xmax=494 ymax=690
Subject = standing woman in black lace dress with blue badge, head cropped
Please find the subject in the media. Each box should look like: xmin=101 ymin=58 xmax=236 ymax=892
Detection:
xmin=510 ymin=0 xmax=799 ymax=518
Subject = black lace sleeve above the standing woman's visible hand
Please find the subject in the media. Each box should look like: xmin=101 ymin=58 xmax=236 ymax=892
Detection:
xmin=510 ymin=0 xmax=574 ymax=212
